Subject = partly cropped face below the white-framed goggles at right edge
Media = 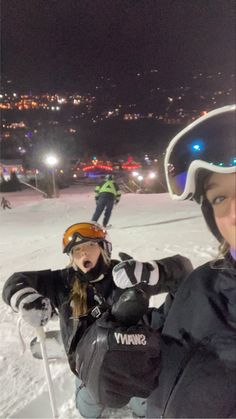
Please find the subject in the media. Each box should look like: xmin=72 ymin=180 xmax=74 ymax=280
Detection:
xmin=206 ymin=173 xmax=236 ymax=249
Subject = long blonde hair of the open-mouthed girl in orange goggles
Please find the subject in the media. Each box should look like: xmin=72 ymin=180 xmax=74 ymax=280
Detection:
xmin=67 ymin=247 xmax=111 ymax=320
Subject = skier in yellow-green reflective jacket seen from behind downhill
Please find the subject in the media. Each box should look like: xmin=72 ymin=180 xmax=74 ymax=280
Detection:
xmin=92 ymin=175 xmax=121 ymax=227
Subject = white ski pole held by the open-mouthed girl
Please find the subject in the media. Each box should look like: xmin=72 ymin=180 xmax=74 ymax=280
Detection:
xmin=36 ymin=326 xmax=58 ymax=419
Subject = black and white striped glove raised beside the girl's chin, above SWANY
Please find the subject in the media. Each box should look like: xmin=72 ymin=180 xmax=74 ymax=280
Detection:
xmin=112 ymin=253 xmax=159 ymax=289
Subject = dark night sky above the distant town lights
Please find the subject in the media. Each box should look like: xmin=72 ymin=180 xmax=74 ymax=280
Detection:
xmin=1 ymin=0 xmax=236 ymax=89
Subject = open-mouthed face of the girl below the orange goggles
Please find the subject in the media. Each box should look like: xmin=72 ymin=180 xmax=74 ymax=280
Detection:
xmin=72 ymin=241 xmax=101 ymax=273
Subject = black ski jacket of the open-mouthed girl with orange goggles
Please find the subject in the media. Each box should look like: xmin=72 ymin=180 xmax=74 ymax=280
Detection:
xmin=2 ymin=255 xmax=192 ymax=374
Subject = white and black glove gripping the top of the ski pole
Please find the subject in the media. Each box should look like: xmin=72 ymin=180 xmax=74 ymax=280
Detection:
xmin=19 ymin=292 xmax=52 ymax=327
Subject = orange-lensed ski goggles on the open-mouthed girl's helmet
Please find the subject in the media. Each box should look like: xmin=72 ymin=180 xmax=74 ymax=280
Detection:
xmin=62 ymin=223 xmax=107 ymax=253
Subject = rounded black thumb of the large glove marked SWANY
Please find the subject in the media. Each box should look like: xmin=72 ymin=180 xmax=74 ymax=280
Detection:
xmin=111 ymin=288 xmax=149 ymax=326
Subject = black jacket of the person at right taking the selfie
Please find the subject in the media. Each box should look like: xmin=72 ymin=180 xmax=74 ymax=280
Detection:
xmin=147 ymin=256 xmax=236 ymax=418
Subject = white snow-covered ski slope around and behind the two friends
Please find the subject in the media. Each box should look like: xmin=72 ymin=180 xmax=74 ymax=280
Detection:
xmin=0 ymin=186 xmax=217 ymax=419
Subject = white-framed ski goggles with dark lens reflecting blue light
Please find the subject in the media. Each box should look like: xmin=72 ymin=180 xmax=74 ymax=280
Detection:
xmin=165 ymin=105 xmax=236 ymax=200
